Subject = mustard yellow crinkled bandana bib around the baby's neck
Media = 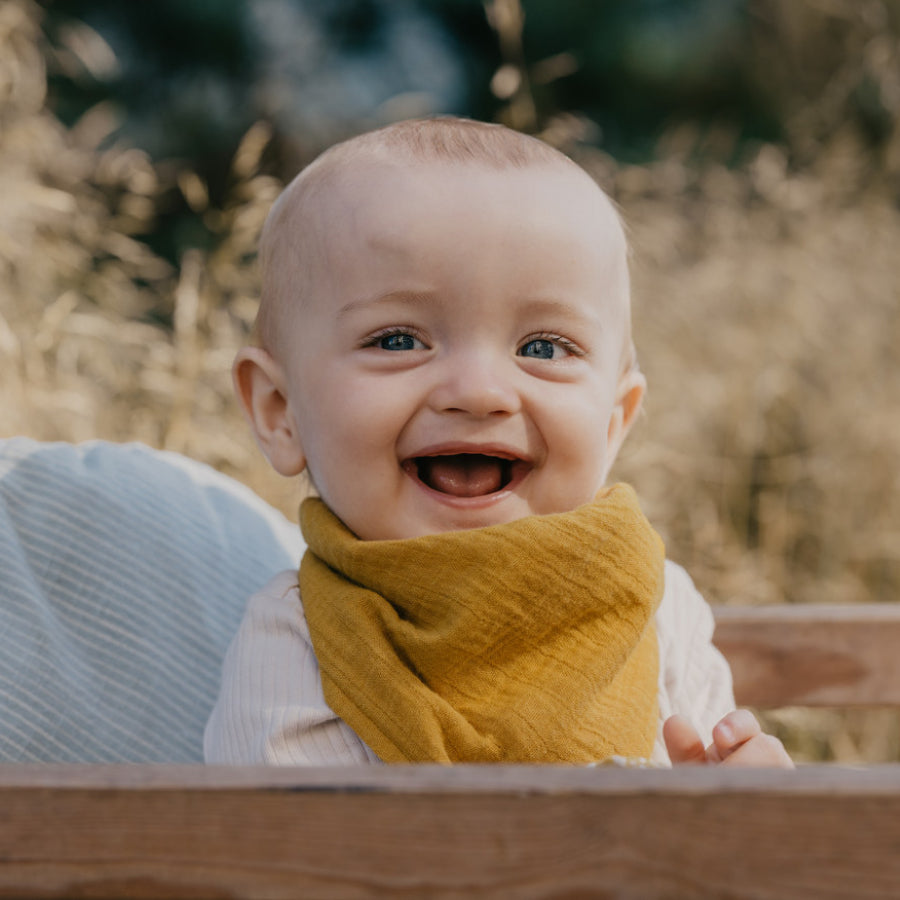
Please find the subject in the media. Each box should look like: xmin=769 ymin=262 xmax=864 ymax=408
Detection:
xmin=299 ymin=484 xmax=664 ymax=763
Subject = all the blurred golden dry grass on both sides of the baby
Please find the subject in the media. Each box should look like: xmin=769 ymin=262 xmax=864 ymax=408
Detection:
xmin=0 ymin=0 xmax=900 ymax=760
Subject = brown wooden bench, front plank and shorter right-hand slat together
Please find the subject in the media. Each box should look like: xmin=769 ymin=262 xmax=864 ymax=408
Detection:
xmin=0 ymin=606 xmax=900 ymax=900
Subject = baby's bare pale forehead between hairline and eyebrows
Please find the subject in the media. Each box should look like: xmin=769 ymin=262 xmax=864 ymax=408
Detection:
xmin=315 ymin=160 xmax=626 ymax=277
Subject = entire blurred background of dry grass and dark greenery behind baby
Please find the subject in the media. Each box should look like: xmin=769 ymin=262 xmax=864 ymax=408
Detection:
xmin=0 ymin=0 xmax=900 ymax=761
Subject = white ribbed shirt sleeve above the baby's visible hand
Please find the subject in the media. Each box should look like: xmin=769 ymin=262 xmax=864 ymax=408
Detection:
xmin=654 ymin=561 xmax=735 ymax=763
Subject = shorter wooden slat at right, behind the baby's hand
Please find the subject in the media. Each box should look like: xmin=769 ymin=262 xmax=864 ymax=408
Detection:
xmin=714 ymin=604 xmax=900 ymax=712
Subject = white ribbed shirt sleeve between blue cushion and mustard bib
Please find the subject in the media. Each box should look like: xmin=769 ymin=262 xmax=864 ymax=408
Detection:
xmin=203 ymin=571 xmax=379 ymax=766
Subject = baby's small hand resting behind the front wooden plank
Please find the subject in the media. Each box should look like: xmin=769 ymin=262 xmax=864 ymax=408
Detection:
xmin=663 ymin=709 xmax=794 ymax=769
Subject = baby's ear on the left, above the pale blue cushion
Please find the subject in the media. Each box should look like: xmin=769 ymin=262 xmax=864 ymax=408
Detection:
xmin=231 ymin=347 xmax=306 ymax=476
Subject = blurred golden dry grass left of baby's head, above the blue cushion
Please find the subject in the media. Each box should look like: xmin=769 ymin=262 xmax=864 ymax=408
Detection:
xmin=0 ymin=0 xmax=295 ymax=508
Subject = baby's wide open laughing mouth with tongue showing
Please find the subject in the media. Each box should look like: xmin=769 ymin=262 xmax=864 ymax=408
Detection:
xmin=403 ymin=453 xmax=530 ymax=497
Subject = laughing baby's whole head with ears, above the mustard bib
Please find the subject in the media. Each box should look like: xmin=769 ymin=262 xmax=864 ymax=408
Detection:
xmin=234 ymin=119 xmax=644 ymax=540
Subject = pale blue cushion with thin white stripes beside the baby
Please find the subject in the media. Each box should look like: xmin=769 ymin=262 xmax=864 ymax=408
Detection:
xmin=0 ymin=438 xmax=302 ymax=762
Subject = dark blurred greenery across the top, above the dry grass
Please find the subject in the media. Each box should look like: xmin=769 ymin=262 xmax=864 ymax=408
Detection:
xmin=40 ymin=0 xmax=900 ymax=261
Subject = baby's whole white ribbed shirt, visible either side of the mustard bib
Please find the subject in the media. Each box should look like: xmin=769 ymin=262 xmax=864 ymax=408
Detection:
xmin=203 ymin=561 xmax=734 ymax=766
